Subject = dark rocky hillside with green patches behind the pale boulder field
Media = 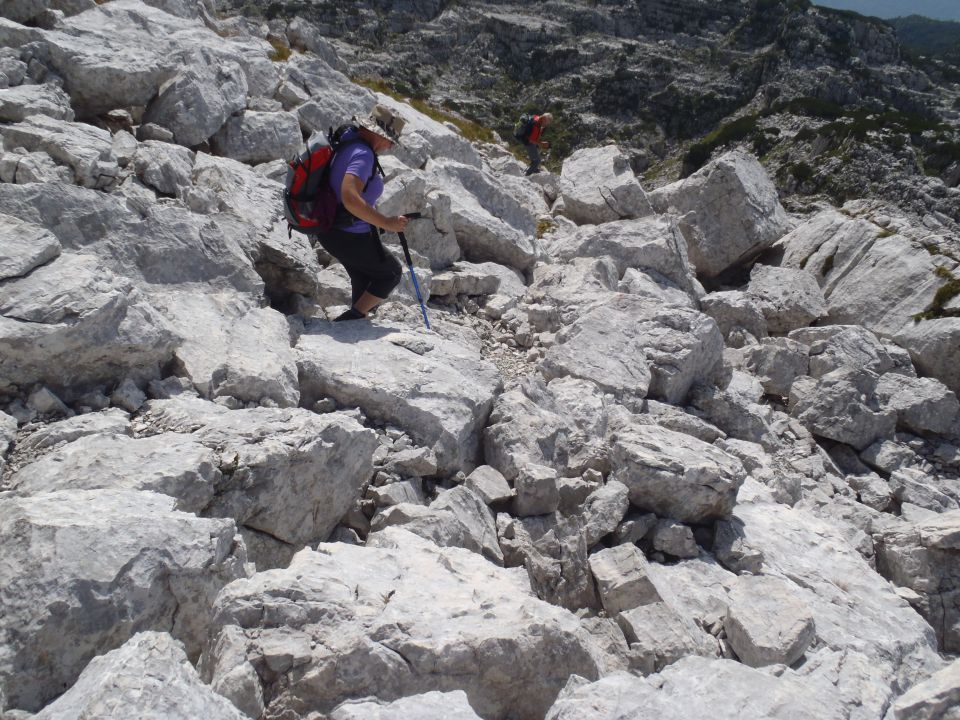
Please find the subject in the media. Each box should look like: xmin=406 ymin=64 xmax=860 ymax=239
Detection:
xmin=217 ymin=0 xmax=960 ymax=238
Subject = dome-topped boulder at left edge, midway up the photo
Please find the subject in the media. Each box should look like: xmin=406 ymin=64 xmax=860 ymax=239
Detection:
xmin=0 ymin=254 xmax=177 ymax=400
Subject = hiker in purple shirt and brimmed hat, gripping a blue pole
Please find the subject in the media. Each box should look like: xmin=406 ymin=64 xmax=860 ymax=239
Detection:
xmin=317 ymin=105 xmax=407 ymax=322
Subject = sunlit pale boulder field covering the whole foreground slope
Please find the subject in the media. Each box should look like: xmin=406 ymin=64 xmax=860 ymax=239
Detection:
xmin=0 ymin=0 xmax=960 ymax=720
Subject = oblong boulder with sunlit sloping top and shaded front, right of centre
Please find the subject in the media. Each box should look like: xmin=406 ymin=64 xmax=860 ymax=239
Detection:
xmin=610 ymin=416 xmax=747 ymax=523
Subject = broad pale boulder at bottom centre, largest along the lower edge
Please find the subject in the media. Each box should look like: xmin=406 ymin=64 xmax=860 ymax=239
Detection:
xmin=205 ymin=528 xmax=605 ymax=720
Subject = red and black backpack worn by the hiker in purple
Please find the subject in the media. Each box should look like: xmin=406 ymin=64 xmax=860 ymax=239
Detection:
xmin=283 ymin=125 xmax=383 ymax=235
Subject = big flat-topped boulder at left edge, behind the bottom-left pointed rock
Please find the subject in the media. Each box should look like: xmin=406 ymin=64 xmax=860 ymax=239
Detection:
xmin=0 ymin=490 xmax=246 ymax=712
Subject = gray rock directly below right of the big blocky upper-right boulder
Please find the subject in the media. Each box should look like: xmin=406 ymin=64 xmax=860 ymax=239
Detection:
xmin=747 ymin=265 xmax=826 ymax=333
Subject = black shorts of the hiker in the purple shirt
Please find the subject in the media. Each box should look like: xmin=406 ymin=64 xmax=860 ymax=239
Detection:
xmin=315 ymin=228 xmax=403 ymax=303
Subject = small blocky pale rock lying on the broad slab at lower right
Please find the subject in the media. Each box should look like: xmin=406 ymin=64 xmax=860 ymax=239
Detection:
xmin=723 ymin=575 xmax=816 ymax=667
